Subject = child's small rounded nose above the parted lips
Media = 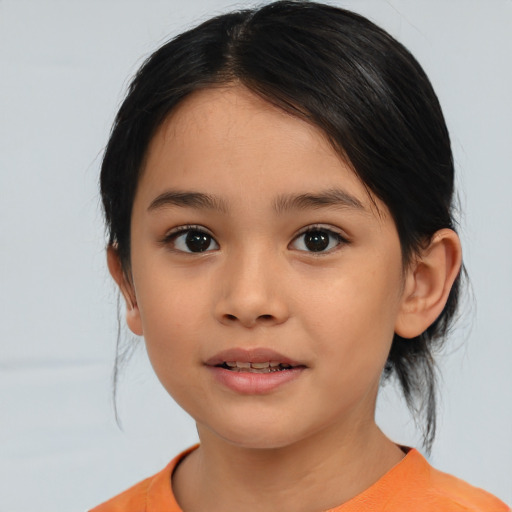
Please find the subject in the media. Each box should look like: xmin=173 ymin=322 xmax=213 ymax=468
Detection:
xmin=215 ymin=251 xmax=289 ymax=328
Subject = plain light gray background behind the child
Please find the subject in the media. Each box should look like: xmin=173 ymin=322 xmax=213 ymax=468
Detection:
xmin=0 ymin=0 xmax=512 ymax=512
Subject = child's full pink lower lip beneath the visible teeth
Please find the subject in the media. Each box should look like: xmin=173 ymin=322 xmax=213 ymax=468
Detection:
xmin=207 ymin=366 xmax=305 ymax=395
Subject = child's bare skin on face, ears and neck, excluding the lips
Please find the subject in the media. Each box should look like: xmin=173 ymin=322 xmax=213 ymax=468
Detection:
xmin=109 ymin=86 xmax=460 ymax=512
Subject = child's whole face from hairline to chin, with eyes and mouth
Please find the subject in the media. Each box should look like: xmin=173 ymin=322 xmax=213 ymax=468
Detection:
xmin=125 ymin=86 xmax=403 ymax=448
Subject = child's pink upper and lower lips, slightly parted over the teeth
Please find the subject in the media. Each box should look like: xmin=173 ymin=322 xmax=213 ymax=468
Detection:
xmin=205 ymin=348 xmax=307 ymax=395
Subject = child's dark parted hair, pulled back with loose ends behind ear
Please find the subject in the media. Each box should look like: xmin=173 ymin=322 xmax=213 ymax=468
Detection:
xmin=101 ymin=1 xmax=460 ymax=449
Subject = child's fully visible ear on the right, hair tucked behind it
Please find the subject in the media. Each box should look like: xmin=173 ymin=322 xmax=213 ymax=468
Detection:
xmin=395 ymin=229 xmax=462 ymax=338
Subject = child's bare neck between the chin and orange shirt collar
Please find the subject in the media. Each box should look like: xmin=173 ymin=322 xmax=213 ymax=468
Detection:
xmin=173 ymin=421 xmax=404 ymax=512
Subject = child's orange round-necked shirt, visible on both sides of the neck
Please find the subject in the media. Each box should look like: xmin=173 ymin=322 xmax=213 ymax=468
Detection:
xmin=90 ymin=447 xmax=510 ymax=512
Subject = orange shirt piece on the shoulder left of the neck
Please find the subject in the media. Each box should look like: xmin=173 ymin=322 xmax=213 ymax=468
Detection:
xmin=89 ymin=445 xmax=197 ymax=512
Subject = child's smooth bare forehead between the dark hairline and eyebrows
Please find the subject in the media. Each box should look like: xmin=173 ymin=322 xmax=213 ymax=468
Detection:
xmin=139 ymin=86 xmax=386 ymax=215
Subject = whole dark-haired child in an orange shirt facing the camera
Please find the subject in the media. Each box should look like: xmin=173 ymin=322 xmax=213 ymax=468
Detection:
xmin=94 ymin=1 xmax=509 ymax=512
